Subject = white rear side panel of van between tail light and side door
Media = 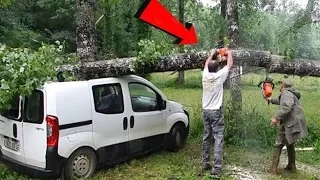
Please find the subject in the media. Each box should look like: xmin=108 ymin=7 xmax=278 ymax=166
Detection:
xmin=46 ymin=81 xmax=94 ymax=158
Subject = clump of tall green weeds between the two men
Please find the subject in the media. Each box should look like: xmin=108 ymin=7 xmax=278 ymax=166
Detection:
xmin=224 ymin=102 xmax=276 ymax=148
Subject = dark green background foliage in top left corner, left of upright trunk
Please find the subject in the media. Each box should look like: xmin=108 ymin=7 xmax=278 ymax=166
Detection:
xmin=0 ymin=0 xmax=75 ymax=53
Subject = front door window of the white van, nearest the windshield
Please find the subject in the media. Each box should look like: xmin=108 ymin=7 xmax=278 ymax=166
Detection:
xmin=129 ymin=83 xmax=161 ymax=112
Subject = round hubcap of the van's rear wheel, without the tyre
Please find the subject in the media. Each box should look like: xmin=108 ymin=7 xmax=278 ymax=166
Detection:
xmin=72 ymin=155 xmax=90 ymax=176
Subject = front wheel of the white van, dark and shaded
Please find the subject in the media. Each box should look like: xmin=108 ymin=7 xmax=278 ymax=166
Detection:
xmin=165 ymin=123 xmax=185 ymax=152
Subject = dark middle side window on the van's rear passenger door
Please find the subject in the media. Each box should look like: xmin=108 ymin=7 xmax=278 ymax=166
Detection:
xmin=92 ymin=83 xmax=124 ymax=114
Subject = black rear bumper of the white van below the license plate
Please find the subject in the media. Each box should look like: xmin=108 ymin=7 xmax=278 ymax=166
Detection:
xmin=0 ymin=147 xmax=64 ymax=178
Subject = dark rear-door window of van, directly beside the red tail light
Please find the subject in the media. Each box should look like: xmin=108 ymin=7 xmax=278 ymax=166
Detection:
xmin=23 ymin=90 xmax=44 ymax=124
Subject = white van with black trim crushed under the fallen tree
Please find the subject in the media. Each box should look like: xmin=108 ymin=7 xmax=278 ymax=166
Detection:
xmin=0 ymin=75 xmax=189 ymax=179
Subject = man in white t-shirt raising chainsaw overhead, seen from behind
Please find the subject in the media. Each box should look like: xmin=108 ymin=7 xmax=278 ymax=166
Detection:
xmin=202 ymin=49 xmax=233 ymax=178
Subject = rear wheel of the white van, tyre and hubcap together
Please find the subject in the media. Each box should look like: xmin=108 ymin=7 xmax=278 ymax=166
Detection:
xmin=62 ymin=148 xmax=97 ymax=180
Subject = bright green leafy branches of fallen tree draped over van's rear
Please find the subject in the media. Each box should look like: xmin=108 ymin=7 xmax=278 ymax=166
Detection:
xmin=0 ymin=41 xmax=75 ymax=109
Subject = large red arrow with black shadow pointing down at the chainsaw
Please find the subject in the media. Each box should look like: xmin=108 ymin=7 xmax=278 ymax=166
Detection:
xmin=135 ymin=0 xmax=198 ymax=45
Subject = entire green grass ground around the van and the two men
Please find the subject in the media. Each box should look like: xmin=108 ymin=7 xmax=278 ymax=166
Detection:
xmin=0 ymin=70 xmax=320 ymax=180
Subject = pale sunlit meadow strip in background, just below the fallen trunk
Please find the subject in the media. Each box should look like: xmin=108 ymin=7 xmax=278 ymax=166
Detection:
xmin=150 ymin=70 xmax=320 ymax=122
